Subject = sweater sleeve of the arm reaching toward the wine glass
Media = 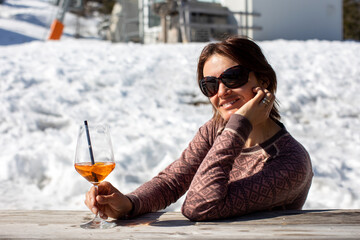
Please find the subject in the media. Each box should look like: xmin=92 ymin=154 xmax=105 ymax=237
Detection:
xmin=126 ymin=120 xmax=216 ymax=218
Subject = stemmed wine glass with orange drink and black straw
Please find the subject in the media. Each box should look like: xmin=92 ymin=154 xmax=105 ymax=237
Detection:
xmin=75 ymin=121 xmax=116 ymax=229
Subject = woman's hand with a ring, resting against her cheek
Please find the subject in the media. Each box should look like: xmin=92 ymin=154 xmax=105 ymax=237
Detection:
xmin=235 ymin=87 xmax=275 ymax=127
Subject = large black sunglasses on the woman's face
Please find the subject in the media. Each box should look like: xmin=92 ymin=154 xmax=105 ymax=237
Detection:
xmin=199 ymin=65 xmax=251 ymax=97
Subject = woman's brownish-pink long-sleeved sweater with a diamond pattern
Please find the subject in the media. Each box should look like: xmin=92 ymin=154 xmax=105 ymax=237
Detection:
xmin=127 ymin=114 xmax=313 ymax=221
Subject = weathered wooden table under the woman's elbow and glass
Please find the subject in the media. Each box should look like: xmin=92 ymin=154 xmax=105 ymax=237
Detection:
xmin=0 ymin=210 xmax=360 ymax=240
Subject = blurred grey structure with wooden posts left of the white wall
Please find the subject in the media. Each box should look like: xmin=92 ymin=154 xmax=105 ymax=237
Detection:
xmin=106 ymin=0 xmax=261 ymax=43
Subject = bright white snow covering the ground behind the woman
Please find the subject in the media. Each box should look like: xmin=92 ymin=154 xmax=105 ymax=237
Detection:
xmin=0 ymin=0 xmax=360 ymax=210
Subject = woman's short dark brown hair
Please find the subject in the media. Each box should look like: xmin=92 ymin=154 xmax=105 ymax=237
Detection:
xmin=197 ymin=37 xmax=280 ymax=122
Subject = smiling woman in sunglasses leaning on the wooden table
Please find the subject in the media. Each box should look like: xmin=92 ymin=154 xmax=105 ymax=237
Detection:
xmin=85 ymin=37 xmax=313 ymax=221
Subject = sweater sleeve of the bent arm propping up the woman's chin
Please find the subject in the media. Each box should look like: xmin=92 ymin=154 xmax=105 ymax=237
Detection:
xmin=182 ymin=114 xmax=312 ymax=221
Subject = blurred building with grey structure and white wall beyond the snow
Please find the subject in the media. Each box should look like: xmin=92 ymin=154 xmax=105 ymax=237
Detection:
xmin=107 ymin=0 xmax=343 ymax=43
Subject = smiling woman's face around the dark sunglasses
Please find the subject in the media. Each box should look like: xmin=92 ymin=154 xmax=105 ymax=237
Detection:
xmin=203 ymin=54 xmax=260 ymax=121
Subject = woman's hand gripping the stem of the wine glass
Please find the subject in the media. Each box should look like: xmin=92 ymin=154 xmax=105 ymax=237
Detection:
xmin=85 ymin=182 xmax=133 ymax=219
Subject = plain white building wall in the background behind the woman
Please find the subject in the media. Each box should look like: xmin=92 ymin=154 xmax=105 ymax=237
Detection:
xmin=222 ymin=0 xmax=342 ymax=40
